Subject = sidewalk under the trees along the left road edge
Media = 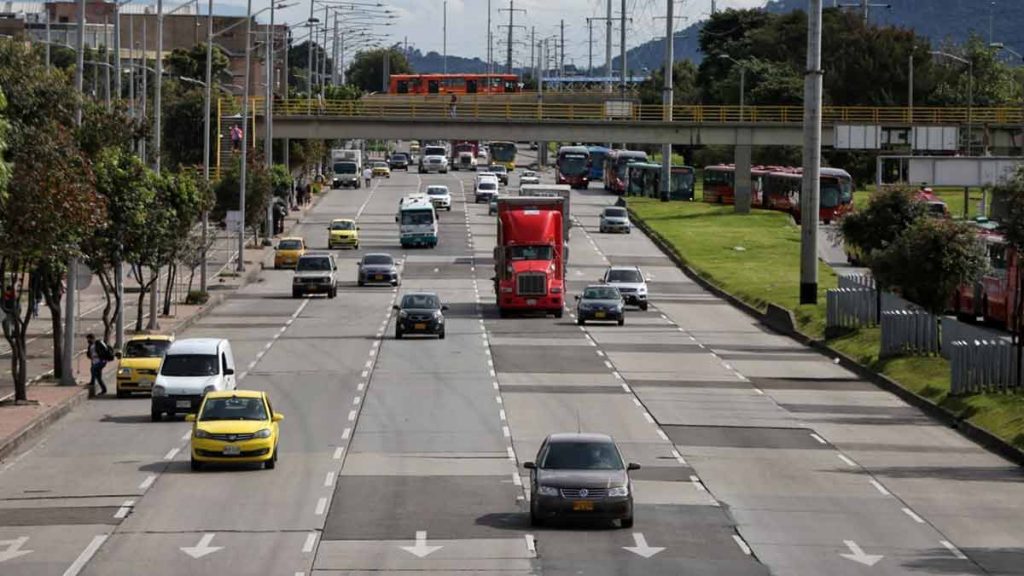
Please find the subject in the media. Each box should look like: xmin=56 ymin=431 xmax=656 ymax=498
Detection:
xmin=0 ymin=194 xmax=325 ymax=461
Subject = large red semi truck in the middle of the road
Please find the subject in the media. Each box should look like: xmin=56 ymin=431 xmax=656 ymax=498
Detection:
xmin=495 ymin=194 xmax=569 ymax=318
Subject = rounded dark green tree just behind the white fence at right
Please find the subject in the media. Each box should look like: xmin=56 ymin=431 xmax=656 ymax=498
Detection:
xmin=870 ymin=218 xmax=988 ymax=314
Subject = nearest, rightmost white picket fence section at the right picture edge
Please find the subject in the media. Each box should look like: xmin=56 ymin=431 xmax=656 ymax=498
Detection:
xmin=949 ymin=339 xmax=1019 ymax=396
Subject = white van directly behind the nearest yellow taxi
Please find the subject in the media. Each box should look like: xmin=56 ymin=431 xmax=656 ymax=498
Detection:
xmin=150 ymin=338 xmax=236 ymax=422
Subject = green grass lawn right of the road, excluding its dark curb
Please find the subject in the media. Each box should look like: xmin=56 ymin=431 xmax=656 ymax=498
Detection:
xmin=630 ymin=199 xmax=1024 ymax=449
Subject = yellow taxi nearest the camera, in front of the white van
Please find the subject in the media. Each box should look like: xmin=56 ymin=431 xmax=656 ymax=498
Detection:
xmin=185 ymin=389 xmax=285 ymax=470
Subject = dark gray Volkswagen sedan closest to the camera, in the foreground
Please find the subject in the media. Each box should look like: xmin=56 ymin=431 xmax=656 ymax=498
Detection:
xmin=523 ymin=433 xmax=640 ymax=528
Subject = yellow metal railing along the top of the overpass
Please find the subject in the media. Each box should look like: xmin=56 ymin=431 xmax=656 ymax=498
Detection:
xmin=232 ymin=98 xmax=1024 ymax=126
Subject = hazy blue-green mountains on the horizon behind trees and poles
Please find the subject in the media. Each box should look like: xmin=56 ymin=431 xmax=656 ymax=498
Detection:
xmin=409 ymin=0 xmax=1024 ymax=74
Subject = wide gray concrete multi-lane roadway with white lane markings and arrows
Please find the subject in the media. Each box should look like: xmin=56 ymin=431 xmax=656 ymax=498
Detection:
xmin=0 ymin=145 xmax=1024 ymax=576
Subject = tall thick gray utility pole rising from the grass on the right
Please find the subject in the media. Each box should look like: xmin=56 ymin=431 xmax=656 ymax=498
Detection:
xmin=800 ymin=0 xmax=822 ymax=304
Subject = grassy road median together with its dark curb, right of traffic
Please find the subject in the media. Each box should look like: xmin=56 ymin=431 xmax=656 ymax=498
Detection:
xmin=629 ymin=198 xmax=1024 ymax=465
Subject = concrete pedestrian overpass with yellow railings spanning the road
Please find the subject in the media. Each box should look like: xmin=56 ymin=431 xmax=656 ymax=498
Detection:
xmin=243 ymin=97 xmax=1024 ymax=147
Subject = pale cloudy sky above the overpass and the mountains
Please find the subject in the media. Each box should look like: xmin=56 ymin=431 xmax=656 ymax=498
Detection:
xmin=214 ymin=0 xmax=766 ymax=66
